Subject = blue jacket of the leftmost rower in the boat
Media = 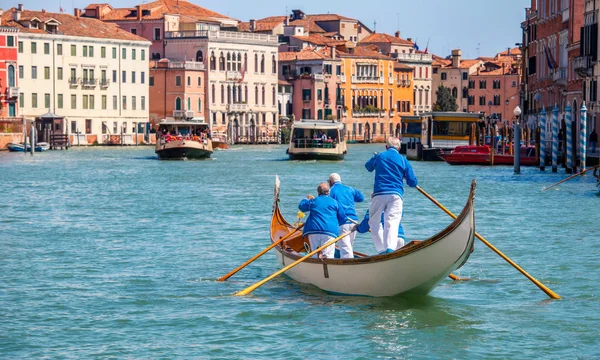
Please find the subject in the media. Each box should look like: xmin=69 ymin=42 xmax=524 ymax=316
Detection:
xmin=298 ymin=195 xmax=346 ymax=237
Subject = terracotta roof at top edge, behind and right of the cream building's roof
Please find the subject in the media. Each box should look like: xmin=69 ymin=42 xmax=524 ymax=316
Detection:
xmin=90 ymin=0 xmax=234 ymax=21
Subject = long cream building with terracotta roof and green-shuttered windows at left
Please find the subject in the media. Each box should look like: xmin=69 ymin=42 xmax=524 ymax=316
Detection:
xmin=2 ymin=5 xmax=150 ymax=145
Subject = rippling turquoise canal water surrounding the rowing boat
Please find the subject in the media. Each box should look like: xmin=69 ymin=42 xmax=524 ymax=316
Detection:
xmin=0 ymin=145 xmax=600 ymax=359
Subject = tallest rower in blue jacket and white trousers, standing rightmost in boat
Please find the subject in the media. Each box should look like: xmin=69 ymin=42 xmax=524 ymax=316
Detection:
xmin=365 ymin=137 xmax=418 ymax=254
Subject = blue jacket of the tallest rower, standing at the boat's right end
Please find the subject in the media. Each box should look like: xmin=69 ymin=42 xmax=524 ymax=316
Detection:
xmin=365 ymin=148 xmax=418 ymax=198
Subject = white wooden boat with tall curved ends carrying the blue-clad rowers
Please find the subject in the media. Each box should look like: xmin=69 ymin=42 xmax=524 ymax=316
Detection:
xmin=271 ymin=178 xmax=476 ymax=297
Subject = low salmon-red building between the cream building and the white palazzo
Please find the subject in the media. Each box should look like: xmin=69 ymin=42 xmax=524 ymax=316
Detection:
xmin=150 ymin=59 xmax=207 ymax=129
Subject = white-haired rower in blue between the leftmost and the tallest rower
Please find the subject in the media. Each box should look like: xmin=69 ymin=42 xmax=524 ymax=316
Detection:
xmin=328 ymin=173 xmax=365 ymax=259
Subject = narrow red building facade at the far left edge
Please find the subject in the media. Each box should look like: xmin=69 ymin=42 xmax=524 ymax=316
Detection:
xmin=0 ymin=27 xmax=19 ymax=118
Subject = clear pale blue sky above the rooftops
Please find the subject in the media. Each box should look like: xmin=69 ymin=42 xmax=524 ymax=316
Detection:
xmin=15 ymin=0 xmax=531 ymax=59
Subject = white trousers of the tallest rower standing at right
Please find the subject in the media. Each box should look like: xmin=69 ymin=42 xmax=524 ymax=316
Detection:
xmin=369 ymin=195 xmax=404 ymax=253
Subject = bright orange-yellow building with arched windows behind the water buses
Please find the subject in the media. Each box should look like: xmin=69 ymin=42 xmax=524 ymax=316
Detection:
xmin=338 ymin=46 xmax=413 ymax=142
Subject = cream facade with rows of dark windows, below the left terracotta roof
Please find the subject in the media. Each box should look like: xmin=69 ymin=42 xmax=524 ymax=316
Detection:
xmin=18 ymin=33 xmax=150 ymax=142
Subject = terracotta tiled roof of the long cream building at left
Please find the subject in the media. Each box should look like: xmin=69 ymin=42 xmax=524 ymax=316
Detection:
xmin=2 ymin=8 xmax=148 ymax=42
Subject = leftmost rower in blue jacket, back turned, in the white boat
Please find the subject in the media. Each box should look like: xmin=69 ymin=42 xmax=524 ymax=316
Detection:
xmin=298 ymin=183 xmax=346 ymax=259
